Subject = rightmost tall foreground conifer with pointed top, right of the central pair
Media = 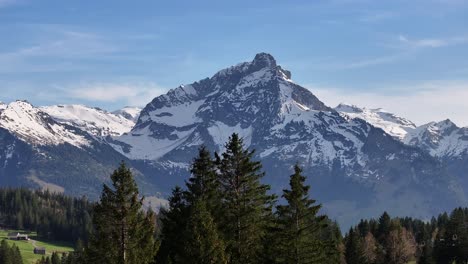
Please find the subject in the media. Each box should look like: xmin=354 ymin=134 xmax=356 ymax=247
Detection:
xmin=276 ymin=165 xmax=332 ymax=264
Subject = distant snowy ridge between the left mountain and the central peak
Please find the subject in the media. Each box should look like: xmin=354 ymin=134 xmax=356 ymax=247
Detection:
xmin=40 ymin=105 xmax=137 ymax=137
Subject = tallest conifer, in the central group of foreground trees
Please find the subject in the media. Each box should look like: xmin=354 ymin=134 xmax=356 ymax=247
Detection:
xmin=216 ymin=134 xmax=274 ymax=264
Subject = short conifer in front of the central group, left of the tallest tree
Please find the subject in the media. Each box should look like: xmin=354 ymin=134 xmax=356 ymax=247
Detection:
xmin=182 ymin=200 xmax=227 ymax=264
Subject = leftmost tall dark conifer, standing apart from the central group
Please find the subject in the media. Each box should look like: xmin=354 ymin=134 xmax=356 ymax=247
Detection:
xmin=88 ymin=163 xmax=157 ymax=264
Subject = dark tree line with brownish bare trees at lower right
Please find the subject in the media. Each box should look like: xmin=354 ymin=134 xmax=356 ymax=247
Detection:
xmin=345 ymin=208 xmax=468 ymax=264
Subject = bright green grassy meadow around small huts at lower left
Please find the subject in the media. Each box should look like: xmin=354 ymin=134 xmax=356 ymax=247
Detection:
xmin=0 ymin=230 xmax=73 ymax=264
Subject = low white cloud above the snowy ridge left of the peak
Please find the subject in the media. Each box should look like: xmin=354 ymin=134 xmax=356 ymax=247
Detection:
xmin=63 ymin=83 xmax=167 ymax=106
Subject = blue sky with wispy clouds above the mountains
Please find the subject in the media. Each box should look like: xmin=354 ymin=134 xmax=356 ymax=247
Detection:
xmin=0 ymin=0 xmax=468 ymax=126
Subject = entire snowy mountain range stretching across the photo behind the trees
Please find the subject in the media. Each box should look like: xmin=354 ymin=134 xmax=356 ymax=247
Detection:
xmin=0 ymin=53 xmax=468 ymax=226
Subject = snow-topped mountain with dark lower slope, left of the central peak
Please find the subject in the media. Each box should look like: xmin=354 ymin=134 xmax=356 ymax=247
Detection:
xmin=0 ymin=101 xmax=156 ymax=198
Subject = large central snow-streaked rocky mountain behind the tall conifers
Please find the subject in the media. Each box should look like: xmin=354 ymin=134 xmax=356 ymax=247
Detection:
xmin=110 ymin=53 xmax=465 ymax=227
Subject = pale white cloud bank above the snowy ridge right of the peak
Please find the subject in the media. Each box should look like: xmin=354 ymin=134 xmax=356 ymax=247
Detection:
xmin=308 ymin=80 xmax=468 ymax=126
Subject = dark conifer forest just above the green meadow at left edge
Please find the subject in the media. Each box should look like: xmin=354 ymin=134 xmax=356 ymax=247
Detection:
xmin=0 ymin=188 xmax=93 ymax=243
